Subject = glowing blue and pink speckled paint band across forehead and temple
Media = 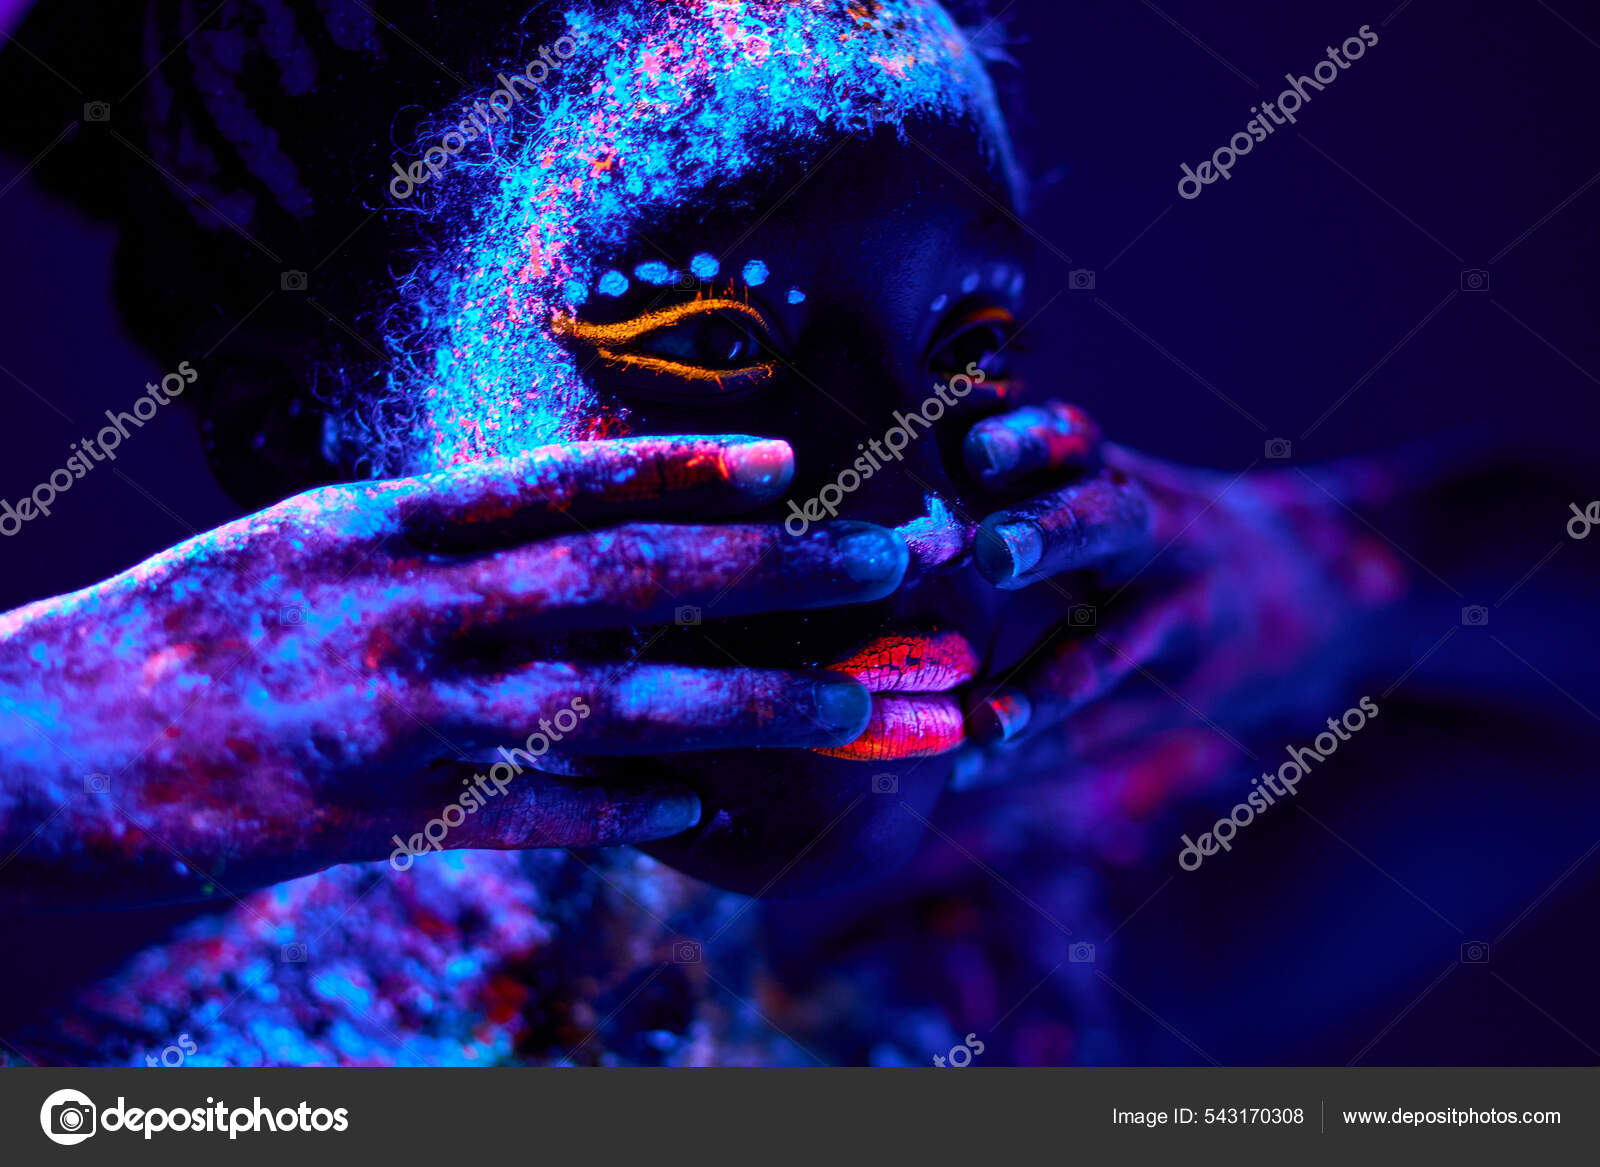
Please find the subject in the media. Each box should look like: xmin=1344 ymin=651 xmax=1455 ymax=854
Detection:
xmin=368 ymin=0 xmax=1021 ymax=475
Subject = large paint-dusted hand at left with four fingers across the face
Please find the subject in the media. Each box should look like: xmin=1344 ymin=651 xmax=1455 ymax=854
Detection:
xmin=0 ymin=437 xmax=907 ymax=904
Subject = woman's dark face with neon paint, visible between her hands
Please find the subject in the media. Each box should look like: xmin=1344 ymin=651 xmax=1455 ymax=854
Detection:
xmin=384 ymin=3 xmax=1062 ymax=895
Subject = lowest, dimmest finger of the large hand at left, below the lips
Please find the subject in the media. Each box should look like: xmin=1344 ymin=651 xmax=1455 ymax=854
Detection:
xmin=387 ymin=764 xmax=701 ymax=871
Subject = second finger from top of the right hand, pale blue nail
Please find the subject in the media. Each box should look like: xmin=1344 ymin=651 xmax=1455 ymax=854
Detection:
xmin=974 ymin=471 xmax=1152 ymax=591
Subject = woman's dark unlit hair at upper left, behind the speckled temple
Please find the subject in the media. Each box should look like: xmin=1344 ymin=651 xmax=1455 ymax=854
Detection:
xmin=0 ymin=0 xmax=997 ymax=507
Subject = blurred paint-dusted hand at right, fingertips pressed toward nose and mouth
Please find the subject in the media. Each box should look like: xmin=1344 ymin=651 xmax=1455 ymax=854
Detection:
xmin=947 ymin=403 xmax=1403 ymax=759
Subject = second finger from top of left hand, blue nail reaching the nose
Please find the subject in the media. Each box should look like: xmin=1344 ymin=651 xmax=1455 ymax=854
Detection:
xmin=419 ymin=522 xmax=910 ymax=634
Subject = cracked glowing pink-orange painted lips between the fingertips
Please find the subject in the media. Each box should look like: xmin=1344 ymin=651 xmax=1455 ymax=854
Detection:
xmin=818 ymin=631 xmax=978 ymax=762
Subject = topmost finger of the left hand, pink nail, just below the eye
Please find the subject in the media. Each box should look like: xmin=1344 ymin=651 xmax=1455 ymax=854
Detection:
xmin=397 ymin=434 xmax=794 ymax=547
